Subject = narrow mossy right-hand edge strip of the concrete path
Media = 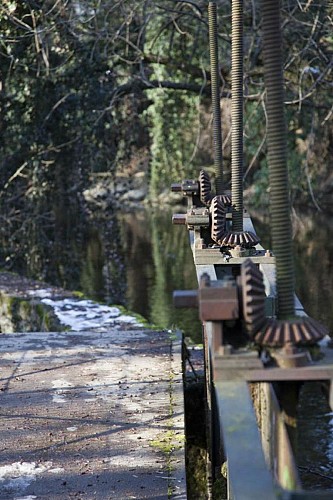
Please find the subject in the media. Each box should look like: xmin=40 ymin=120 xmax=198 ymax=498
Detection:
xmin=170 ymin=331 xmax=187 ymax=500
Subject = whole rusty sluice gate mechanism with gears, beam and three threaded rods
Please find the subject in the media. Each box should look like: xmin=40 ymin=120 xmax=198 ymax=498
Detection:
xmin=172 ymin=0 xmax=333 ymax=500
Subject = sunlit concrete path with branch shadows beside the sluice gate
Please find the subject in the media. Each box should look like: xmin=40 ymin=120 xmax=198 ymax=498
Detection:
xmin=0 ymin=325 xmax=186 ymax=500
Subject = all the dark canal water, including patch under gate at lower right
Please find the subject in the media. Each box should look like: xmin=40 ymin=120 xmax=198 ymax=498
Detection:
xmin=1 ymin=204 xmax=333 ymax=489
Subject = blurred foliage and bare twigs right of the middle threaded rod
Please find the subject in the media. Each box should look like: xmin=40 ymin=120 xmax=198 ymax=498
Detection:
xmin=245 ymin=2 xmax=333 ymax=206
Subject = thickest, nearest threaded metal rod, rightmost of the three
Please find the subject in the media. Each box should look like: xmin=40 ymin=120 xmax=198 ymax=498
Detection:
xmin=261 ymin=0 xmax=295 ymax=319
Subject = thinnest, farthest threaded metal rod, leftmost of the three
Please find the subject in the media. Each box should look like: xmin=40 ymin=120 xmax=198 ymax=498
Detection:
xmin=208 ymin=2 xmax=223 ymax=194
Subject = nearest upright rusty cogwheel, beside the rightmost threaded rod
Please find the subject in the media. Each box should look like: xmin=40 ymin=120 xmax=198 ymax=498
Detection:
xmin=240 ymin=259 xmax=266 ymax=337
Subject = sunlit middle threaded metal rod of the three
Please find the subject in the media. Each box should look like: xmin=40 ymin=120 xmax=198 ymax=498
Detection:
xmin=231 ymin=0 xmax=243 ymax=231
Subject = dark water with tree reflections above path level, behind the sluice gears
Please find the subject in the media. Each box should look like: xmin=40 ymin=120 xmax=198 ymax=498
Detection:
xmin=0 ymin=203 xmax=333 ymax=340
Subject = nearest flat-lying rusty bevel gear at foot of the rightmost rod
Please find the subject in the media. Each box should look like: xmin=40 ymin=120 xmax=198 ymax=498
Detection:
xmin=254 ymin=316 xmax=328 ymax=347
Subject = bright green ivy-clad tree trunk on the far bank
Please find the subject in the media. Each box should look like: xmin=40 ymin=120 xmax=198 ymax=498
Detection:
xmin=145 ymin=1 xmax=209 ymax=197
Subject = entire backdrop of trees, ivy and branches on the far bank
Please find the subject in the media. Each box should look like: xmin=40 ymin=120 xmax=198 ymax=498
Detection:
xmin=0 ymin=0 xmax=333 ymax=290
